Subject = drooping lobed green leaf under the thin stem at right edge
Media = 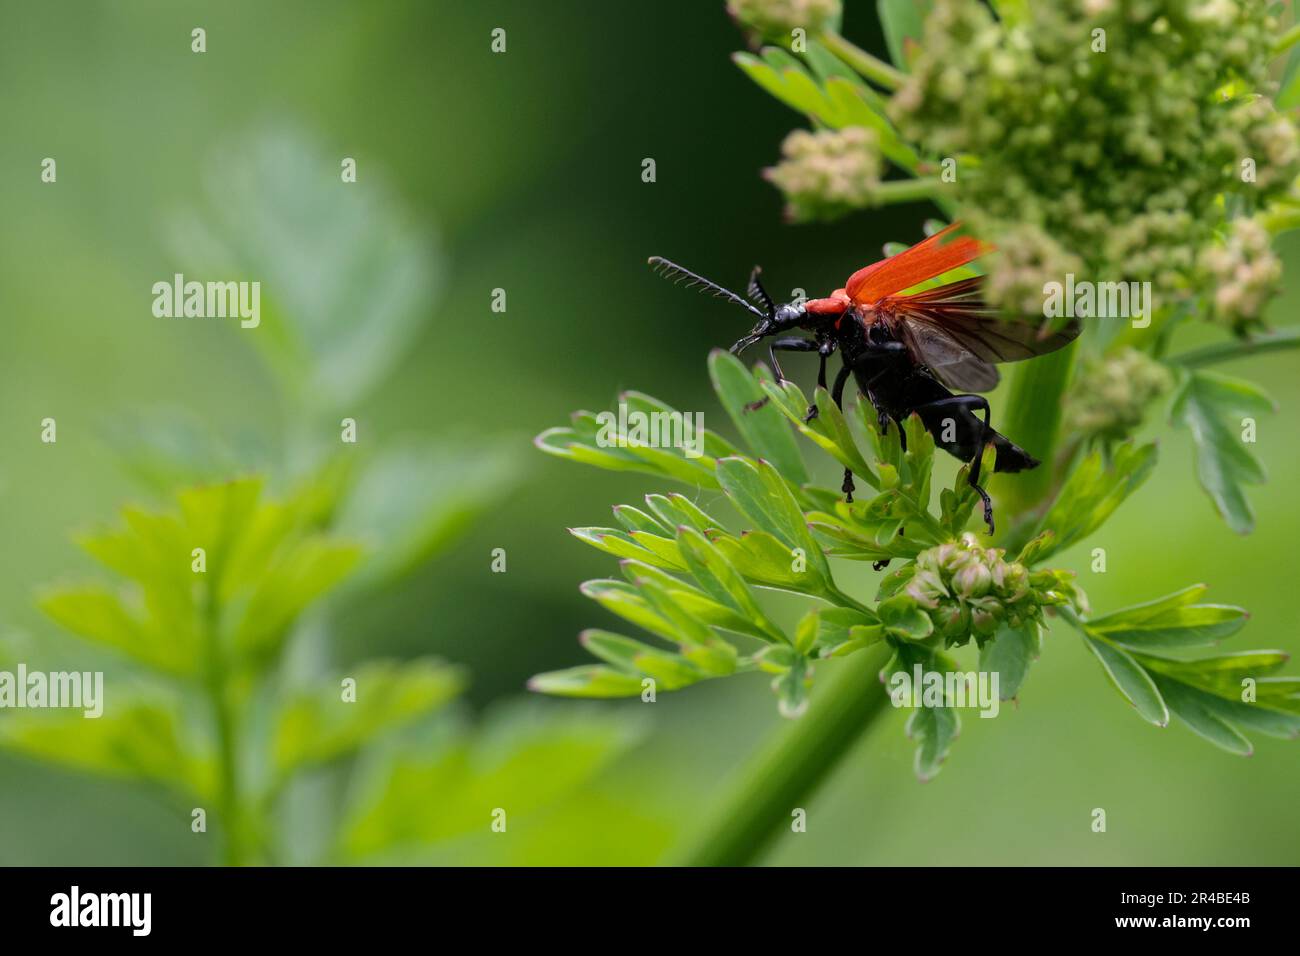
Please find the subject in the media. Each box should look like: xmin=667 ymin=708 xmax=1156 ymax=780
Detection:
xmin=1170 ymin=371 xmax=1274 ymax=535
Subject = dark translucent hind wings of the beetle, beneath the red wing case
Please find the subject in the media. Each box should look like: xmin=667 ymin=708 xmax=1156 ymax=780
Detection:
xmin=876 ymin=276 xmax=1079 ymax=392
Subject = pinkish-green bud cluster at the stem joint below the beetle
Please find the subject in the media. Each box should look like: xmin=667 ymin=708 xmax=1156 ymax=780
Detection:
xmin=887 ymin=533 xmax=1087 ymax=646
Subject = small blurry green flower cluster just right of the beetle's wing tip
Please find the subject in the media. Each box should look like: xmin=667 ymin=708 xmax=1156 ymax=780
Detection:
xmin=1066 ymin=349 xmax=1174 ymax=441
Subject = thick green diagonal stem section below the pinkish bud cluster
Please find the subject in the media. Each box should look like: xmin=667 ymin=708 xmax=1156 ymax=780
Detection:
xmin=672 ymin=643 xmax=891 ymax=866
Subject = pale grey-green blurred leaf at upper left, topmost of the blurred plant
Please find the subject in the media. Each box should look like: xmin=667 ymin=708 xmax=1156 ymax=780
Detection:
xmin=173 ymin=122 xmax=442 ymax=412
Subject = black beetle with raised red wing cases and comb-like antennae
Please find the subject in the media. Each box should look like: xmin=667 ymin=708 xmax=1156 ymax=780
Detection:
xmin=649 ymin=222 xmax=1079 ymax=535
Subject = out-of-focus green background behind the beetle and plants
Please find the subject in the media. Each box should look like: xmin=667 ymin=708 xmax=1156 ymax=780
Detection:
xmin=0 ymin=0 xmax=1300 ymax=865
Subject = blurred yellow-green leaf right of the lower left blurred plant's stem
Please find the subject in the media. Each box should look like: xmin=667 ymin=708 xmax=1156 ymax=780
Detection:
xmin=272 ymin=659 xmax=464 ymax=775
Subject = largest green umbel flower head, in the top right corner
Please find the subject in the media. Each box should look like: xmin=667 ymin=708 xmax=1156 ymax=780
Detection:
xmin=891 ymin=0 xmax=1300 ymax=321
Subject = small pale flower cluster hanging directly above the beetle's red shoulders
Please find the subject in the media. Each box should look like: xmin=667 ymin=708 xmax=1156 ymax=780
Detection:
xmin=763 ymin=126 xmax=880 ymax=221
